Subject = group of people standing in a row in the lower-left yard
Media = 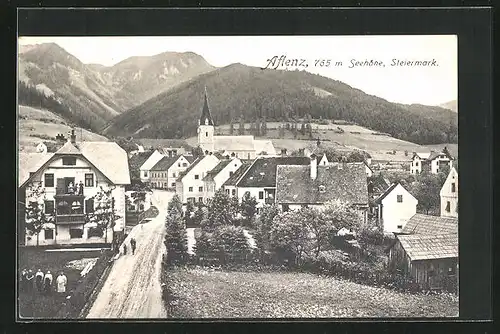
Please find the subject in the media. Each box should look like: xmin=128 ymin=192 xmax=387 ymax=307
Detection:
xmin=20 ymin=269 xmax=68 ymax=293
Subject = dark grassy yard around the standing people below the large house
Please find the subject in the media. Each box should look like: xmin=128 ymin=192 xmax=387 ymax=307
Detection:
xmin=18 ymin=248 xmax=100 ymax=318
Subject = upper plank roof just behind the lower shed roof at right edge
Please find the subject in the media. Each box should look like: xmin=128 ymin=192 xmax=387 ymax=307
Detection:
xmin=401 ymin=213 xmax=458 ymax=234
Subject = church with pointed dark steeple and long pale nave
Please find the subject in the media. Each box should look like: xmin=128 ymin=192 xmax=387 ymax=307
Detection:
xmin=198 ymin=91 xmax=276 ymax=160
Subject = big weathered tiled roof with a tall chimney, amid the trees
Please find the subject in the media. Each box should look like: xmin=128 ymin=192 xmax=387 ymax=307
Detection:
xmin=276 ymin=164 xmax=368 ymax=205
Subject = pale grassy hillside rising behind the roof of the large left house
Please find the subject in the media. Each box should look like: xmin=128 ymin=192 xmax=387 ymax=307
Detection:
xmin=18 ymin=106 xmax=108 ymax=152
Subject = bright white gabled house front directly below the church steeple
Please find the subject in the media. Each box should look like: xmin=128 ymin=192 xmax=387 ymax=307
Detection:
xmin=176 ymin=154 xmax=220 ymax=204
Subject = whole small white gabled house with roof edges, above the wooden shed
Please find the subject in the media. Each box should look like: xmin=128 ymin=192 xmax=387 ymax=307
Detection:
xmin=374 ymin=183 xmax=418 ymax=233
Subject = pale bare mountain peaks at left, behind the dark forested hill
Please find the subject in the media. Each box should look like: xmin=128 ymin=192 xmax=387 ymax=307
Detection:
xmin=18 ymin=43 xmax=213 ymax=132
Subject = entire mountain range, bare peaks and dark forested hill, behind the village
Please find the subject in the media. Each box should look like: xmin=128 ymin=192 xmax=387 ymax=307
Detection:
xmin=19 ymin=43 xmax=458 ymax=144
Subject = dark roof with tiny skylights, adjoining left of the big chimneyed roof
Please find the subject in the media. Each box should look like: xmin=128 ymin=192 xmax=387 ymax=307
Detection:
xmin=237 ymin=157 xmax=310 ymax=187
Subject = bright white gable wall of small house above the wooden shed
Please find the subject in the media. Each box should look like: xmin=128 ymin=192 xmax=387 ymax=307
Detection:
xmin=382 ymin=184 xmax=418 ymax=233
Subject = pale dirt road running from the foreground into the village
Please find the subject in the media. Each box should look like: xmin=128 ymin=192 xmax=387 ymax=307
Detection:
xmin=87 ymin=190 xmax=173 ymax=319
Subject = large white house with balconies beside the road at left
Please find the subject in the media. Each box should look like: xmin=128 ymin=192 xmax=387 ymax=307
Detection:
xmin=18 ymin=131 xmax=130 ymax=245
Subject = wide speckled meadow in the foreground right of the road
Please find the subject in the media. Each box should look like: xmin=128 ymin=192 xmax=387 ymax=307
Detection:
xmin=167 ymin=268 xmax=458 ymax=318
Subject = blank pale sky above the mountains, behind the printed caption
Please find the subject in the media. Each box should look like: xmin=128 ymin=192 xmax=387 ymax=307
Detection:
xmin=19 ymin=35 xmax=458 ymax=105
